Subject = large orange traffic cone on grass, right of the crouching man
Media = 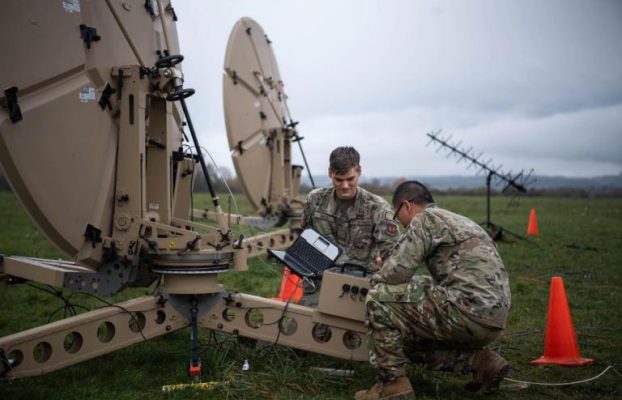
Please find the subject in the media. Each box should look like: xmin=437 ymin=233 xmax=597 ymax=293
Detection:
xmin=531 ymin=276 xmax=593 ymax=367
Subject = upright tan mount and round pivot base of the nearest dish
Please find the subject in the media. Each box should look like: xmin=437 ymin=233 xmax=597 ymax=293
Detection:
xmin=0 ymin=58 xmax=252 ymax=293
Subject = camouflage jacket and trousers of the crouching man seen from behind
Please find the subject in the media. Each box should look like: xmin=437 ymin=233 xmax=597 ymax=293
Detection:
xmin=366 ymin=204 xmax=510 ymax=379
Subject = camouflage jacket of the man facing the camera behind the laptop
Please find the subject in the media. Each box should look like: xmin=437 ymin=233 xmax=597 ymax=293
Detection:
xmin=302 ymin=187 xmax=399 ymax=271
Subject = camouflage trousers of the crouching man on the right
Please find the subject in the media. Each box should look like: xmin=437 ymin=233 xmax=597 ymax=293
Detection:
xmin=365 ymin=275 xmax=501 ymax=379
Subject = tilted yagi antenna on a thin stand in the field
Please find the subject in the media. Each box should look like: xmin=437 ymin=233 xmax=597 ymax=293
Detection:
xmin=426 ymin=130 xmax=536 ymax=239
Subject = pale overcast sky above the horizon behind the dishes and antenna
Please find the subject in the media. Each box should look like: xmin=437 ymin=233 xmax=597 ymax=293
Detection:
xmin=173 ymin=0 xmax=622 ymax=177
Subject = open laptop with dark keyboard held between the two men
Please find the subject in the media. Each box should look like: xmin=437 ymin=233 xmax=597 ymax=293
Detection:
xmin=268 ymin=228 xmax=341 ymax=278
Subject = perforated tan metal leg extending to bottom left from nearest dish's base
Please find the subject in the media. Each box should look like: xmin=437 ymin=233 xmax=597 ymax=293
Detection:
xmin=0 ymin=297 xmax=188 ymax=378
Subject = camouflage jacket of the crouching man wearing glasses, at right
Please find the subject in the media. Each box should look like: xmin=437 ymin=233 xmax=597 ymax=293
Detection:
xmin=372 ymin=204 xmax=511 ymax=328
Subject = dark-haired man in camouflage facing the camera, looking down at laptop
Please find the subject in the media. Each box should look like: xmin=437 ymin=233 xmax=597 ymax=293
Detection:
xmin=302 ymin=147 xmax=398 ymax=306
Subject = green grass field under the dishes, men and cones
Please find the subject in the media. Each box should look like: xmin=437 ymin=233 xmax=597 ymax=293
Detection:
xmin=0 ymin=192 xmax=622 ymax=400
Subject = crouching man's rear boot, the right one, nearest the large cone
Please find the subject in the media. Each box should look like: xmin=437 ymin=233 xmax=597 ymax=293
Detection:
xmin=465 ymin=349 xmax=510 ymax=393
